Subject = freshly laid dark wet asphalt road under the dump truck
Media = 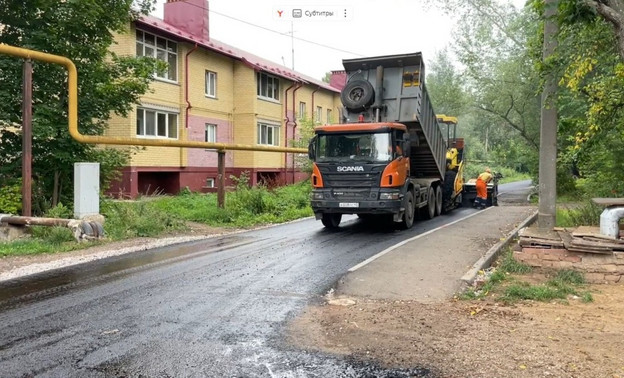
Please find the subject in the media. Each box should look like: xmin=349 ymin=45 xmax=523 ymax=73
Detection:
xmin=0 ymin=182 xmax=526 ymax=377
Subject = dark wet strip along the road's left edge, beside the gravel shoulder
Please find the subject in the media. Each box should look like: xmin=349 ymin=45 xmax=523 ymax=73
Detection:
xmin=0 ymin=235 xmax=257 ymax=309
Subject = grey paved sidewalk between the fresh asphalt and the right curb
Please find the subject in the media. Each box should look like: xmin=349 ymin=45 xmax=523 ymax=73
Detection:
xmin=334 ymin=205 xmax=536 ymax=303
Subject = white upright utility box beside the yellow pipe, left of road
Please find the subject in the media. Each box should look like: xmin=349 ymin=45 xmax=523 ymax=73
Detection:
xmin=74 ymin=163 xmax=100 ymax=219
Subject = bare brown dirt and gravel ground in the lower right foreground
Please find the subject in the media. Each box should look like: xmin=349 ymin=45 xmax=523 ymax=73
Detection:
xmin=288 ymin=277 xmax=624 ymax=377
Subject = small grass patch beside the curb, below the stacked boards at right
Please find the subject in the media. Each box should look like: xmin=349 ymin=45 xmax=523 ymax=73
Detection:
xmin=458 ymin=248 xmax=593 ymax=303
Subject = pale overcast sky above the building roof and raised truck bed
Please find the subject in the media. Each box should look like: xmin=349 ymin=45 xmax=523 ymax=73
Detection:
xmin=153 ymin=0 xmax=468 ymax=79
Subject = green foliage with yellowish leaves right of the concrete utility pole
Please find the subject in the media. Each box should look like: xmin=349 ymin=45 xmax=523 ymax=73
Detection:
xmin=544 ymin=1 xmax=624 ymax=196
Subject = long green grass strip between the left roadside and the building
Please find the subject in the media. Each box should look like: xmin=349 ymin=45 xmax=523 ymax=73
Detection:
xmin=0 ymin=179 xmax=313 ymax=257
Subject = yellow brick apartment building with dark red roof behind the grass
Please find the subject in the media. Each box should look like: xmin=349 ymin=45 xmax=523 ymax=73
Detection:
xmin=107 ymin=0 xmax=340 ymax=198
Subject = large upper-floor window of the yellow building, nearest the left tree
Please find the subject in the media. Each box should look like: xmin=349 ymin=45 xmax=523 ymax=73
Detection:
xmin=136 ymin=29 xmax=178 ymax=81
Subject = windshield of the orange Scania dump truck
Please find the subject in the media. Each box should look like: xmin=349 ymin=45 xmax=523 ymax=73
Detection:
xmin=316 ymin=133 xmax=392 ymax=163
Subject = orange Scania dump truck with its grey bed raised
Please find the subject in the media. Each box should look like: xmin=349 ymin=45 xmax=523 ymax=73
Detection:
xmin=308 ymin=53 xmax=463 ymax=228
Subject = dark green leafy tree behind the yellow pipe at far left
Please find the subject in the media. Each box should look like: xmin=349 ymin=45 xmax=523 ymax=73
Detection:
xmin=0 ymin=0 xmax=163 ymax=212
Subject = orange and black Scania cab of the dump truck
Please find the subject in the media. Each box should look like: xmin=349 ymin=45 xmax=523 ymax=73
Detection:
xmin=309 ymin=123 xmax=409 ymax=227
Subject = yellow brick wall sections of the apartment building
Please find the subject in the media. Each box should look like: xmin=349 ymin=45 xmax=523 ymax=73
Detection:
xmin=106 ymin=21 xmax=341 ymax=169
